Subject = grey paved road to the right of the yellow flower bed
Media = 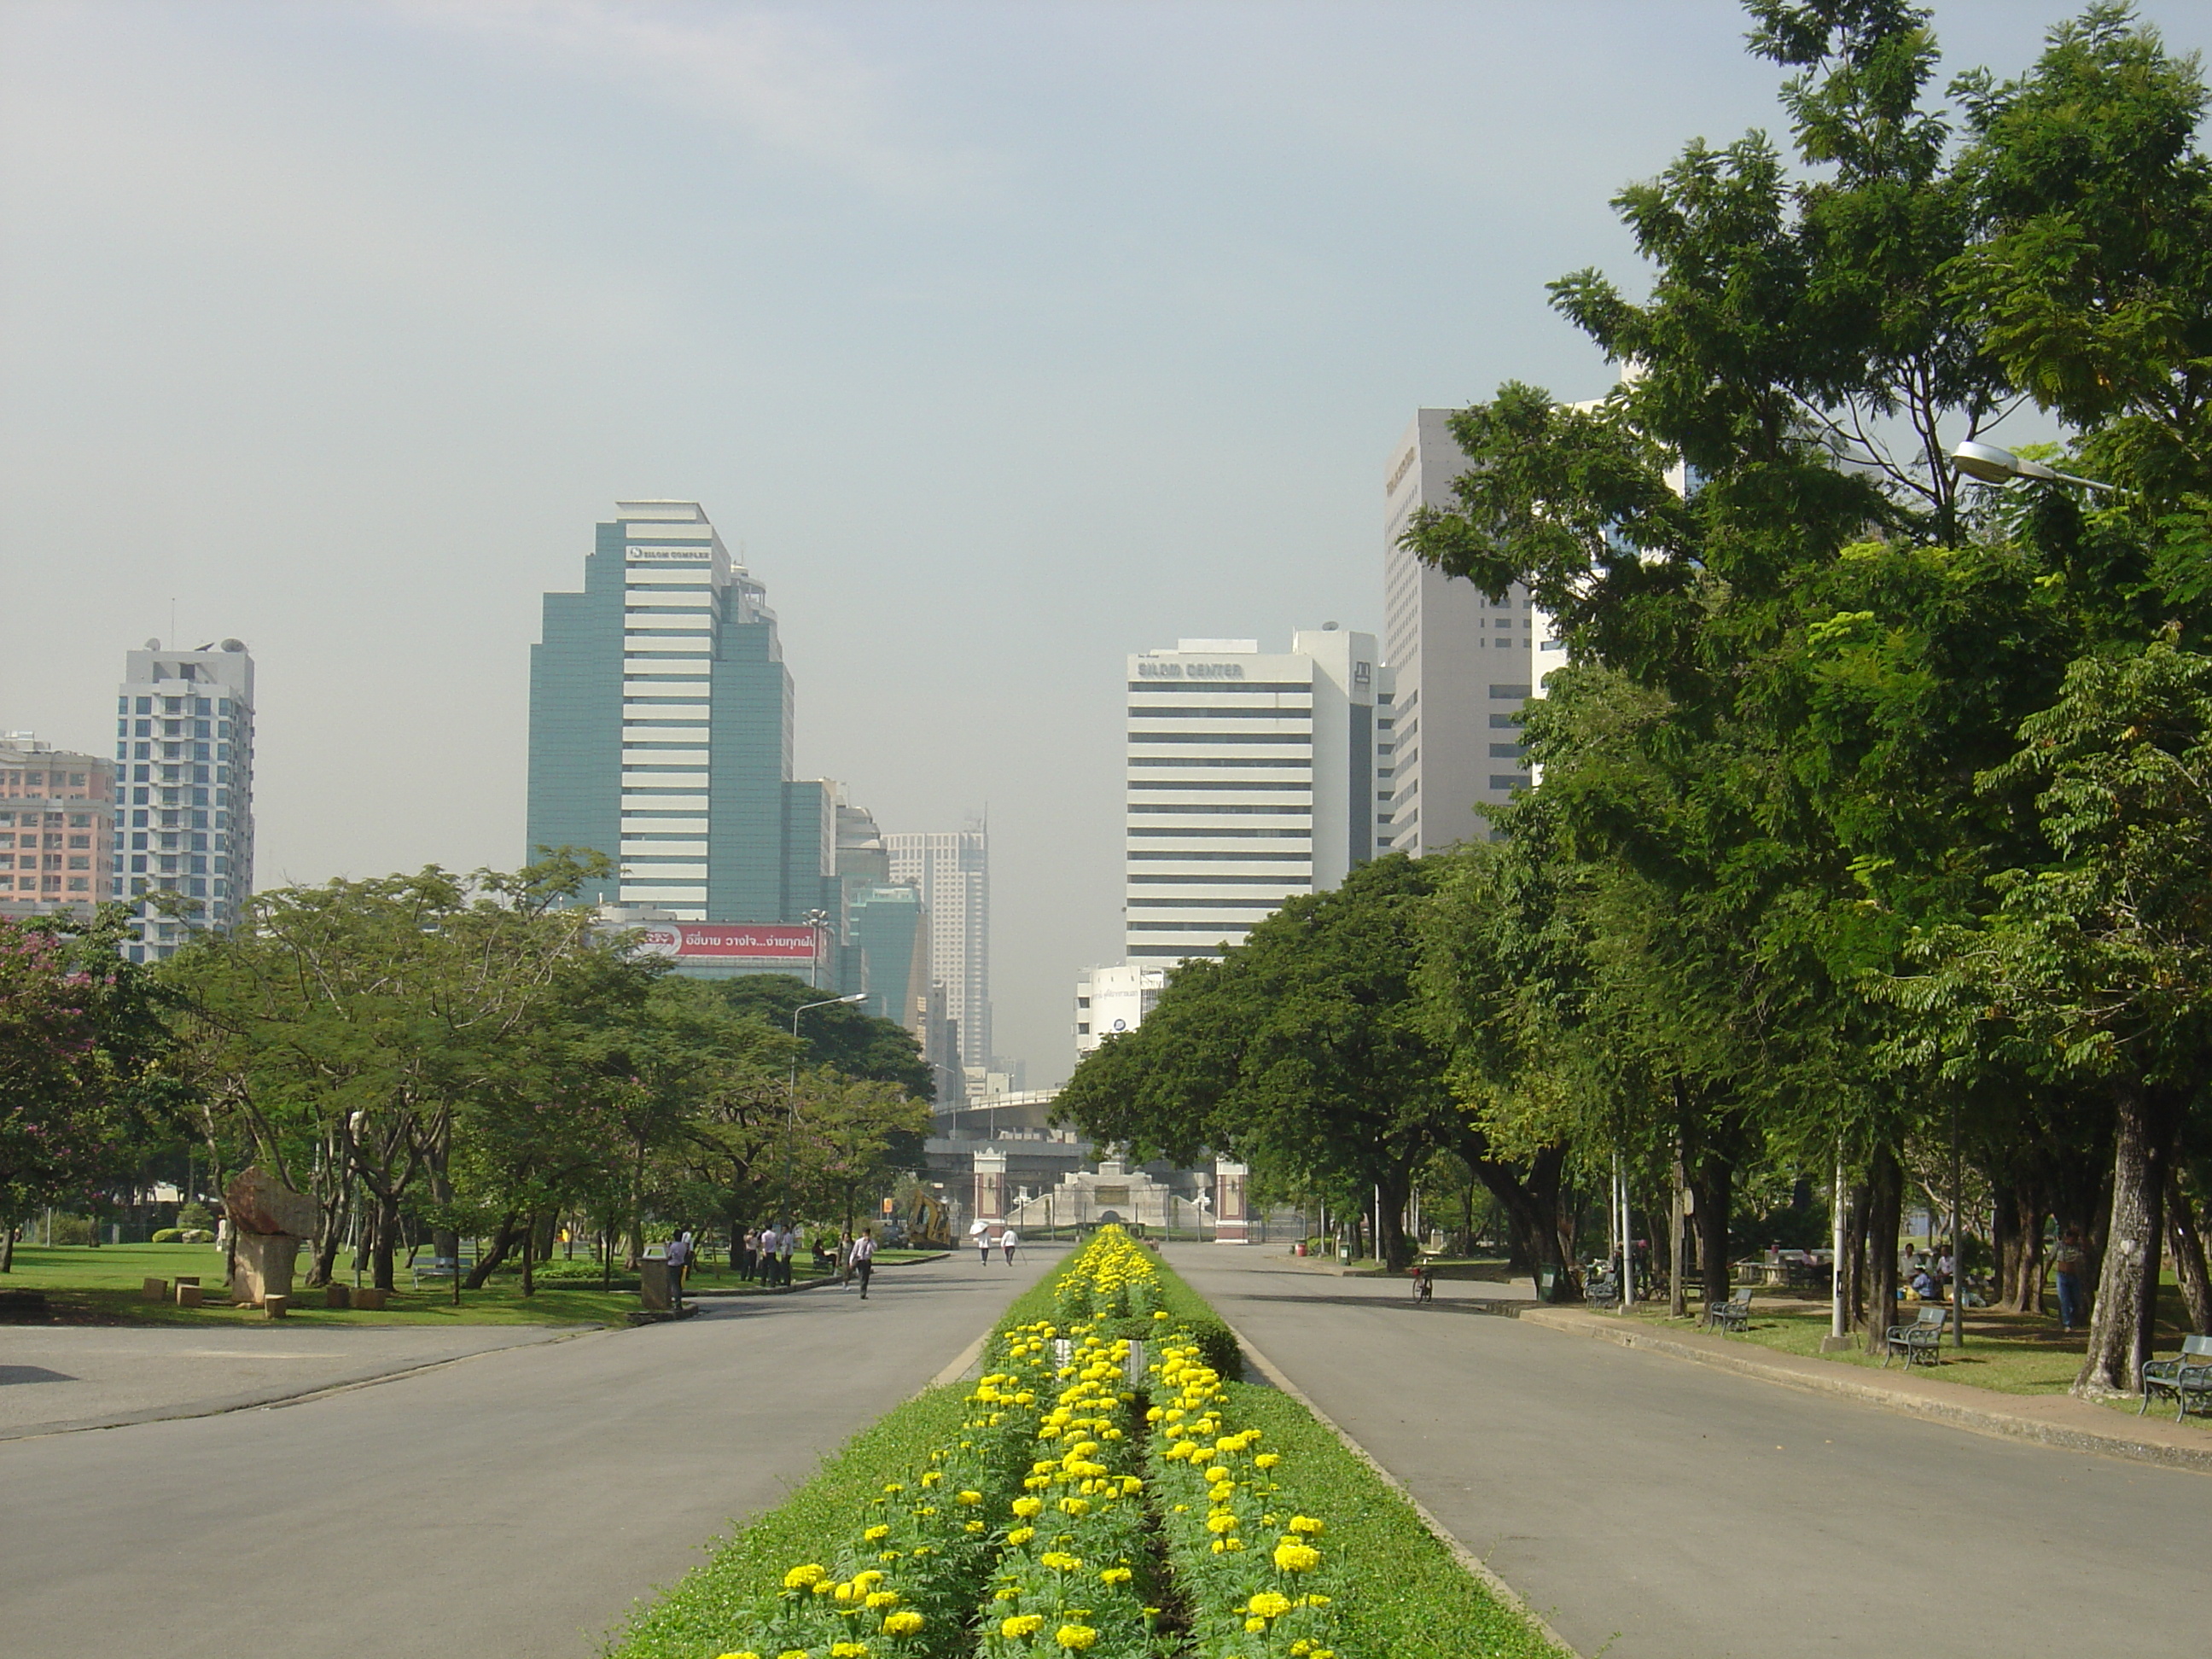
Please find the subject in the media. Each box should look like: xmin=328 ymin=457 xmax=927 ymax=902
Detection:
xmin=1170 ymin=1245 xmax=2212 ymax=1659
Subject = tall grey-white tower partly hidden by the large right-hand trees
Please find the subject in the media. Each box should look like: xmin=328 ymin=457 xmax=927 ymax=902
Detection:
xmin=1378 ymin=410 xmax=1566 ymax=856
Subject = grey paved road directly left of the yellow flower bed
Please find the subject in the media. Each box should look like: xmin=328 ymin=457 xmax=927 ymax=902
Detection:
xmin=0 ymin=1248 xmax=1057 ymax=1659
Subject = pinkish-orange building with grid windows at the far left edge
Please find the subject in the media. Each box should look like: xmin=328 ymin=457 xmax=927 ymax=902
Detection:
xmin=0 ymin=732 xmax=115 ymax=920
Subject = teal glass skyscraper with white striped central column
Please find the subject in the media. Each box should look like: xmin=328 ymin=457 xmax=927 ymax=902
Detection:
xmin=528 ymin=500 xmax=843 ymax=927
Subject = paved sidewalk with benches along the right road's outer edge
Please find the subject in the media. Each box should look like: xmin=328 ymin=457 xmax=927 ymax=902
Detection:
xmin=1517 ymin=1305 xmax=2212 ymax=1473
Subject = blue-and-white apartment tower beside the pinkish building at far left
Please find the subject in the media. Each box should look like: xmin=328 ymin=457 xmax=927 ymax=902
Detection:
xmin=108 ymin=639 xmax=254 ymax=963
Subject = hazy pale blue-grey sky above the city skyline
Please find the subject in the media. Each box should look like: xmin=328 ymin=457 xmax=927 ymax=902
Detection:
xmin=0 ymin=0 xmax=2212 ymax=1081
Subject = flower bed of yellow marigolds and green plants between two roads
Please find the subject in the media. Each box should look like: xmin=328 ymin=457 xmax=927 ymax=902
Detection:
xmin=617 ymin=1228 xmax=1544 ymax=1659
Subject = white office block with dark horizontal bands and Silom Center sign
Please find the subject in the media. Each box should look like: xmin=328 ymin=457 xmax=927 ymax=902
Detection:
xmin=1124 ymin=624 xmax=1389 ymax=967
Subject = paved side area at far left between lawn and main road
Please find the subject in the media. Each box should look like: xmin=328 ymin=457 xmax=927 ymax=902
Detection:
xmin=0 ymin=1323 xmax=568 ymax=1440
